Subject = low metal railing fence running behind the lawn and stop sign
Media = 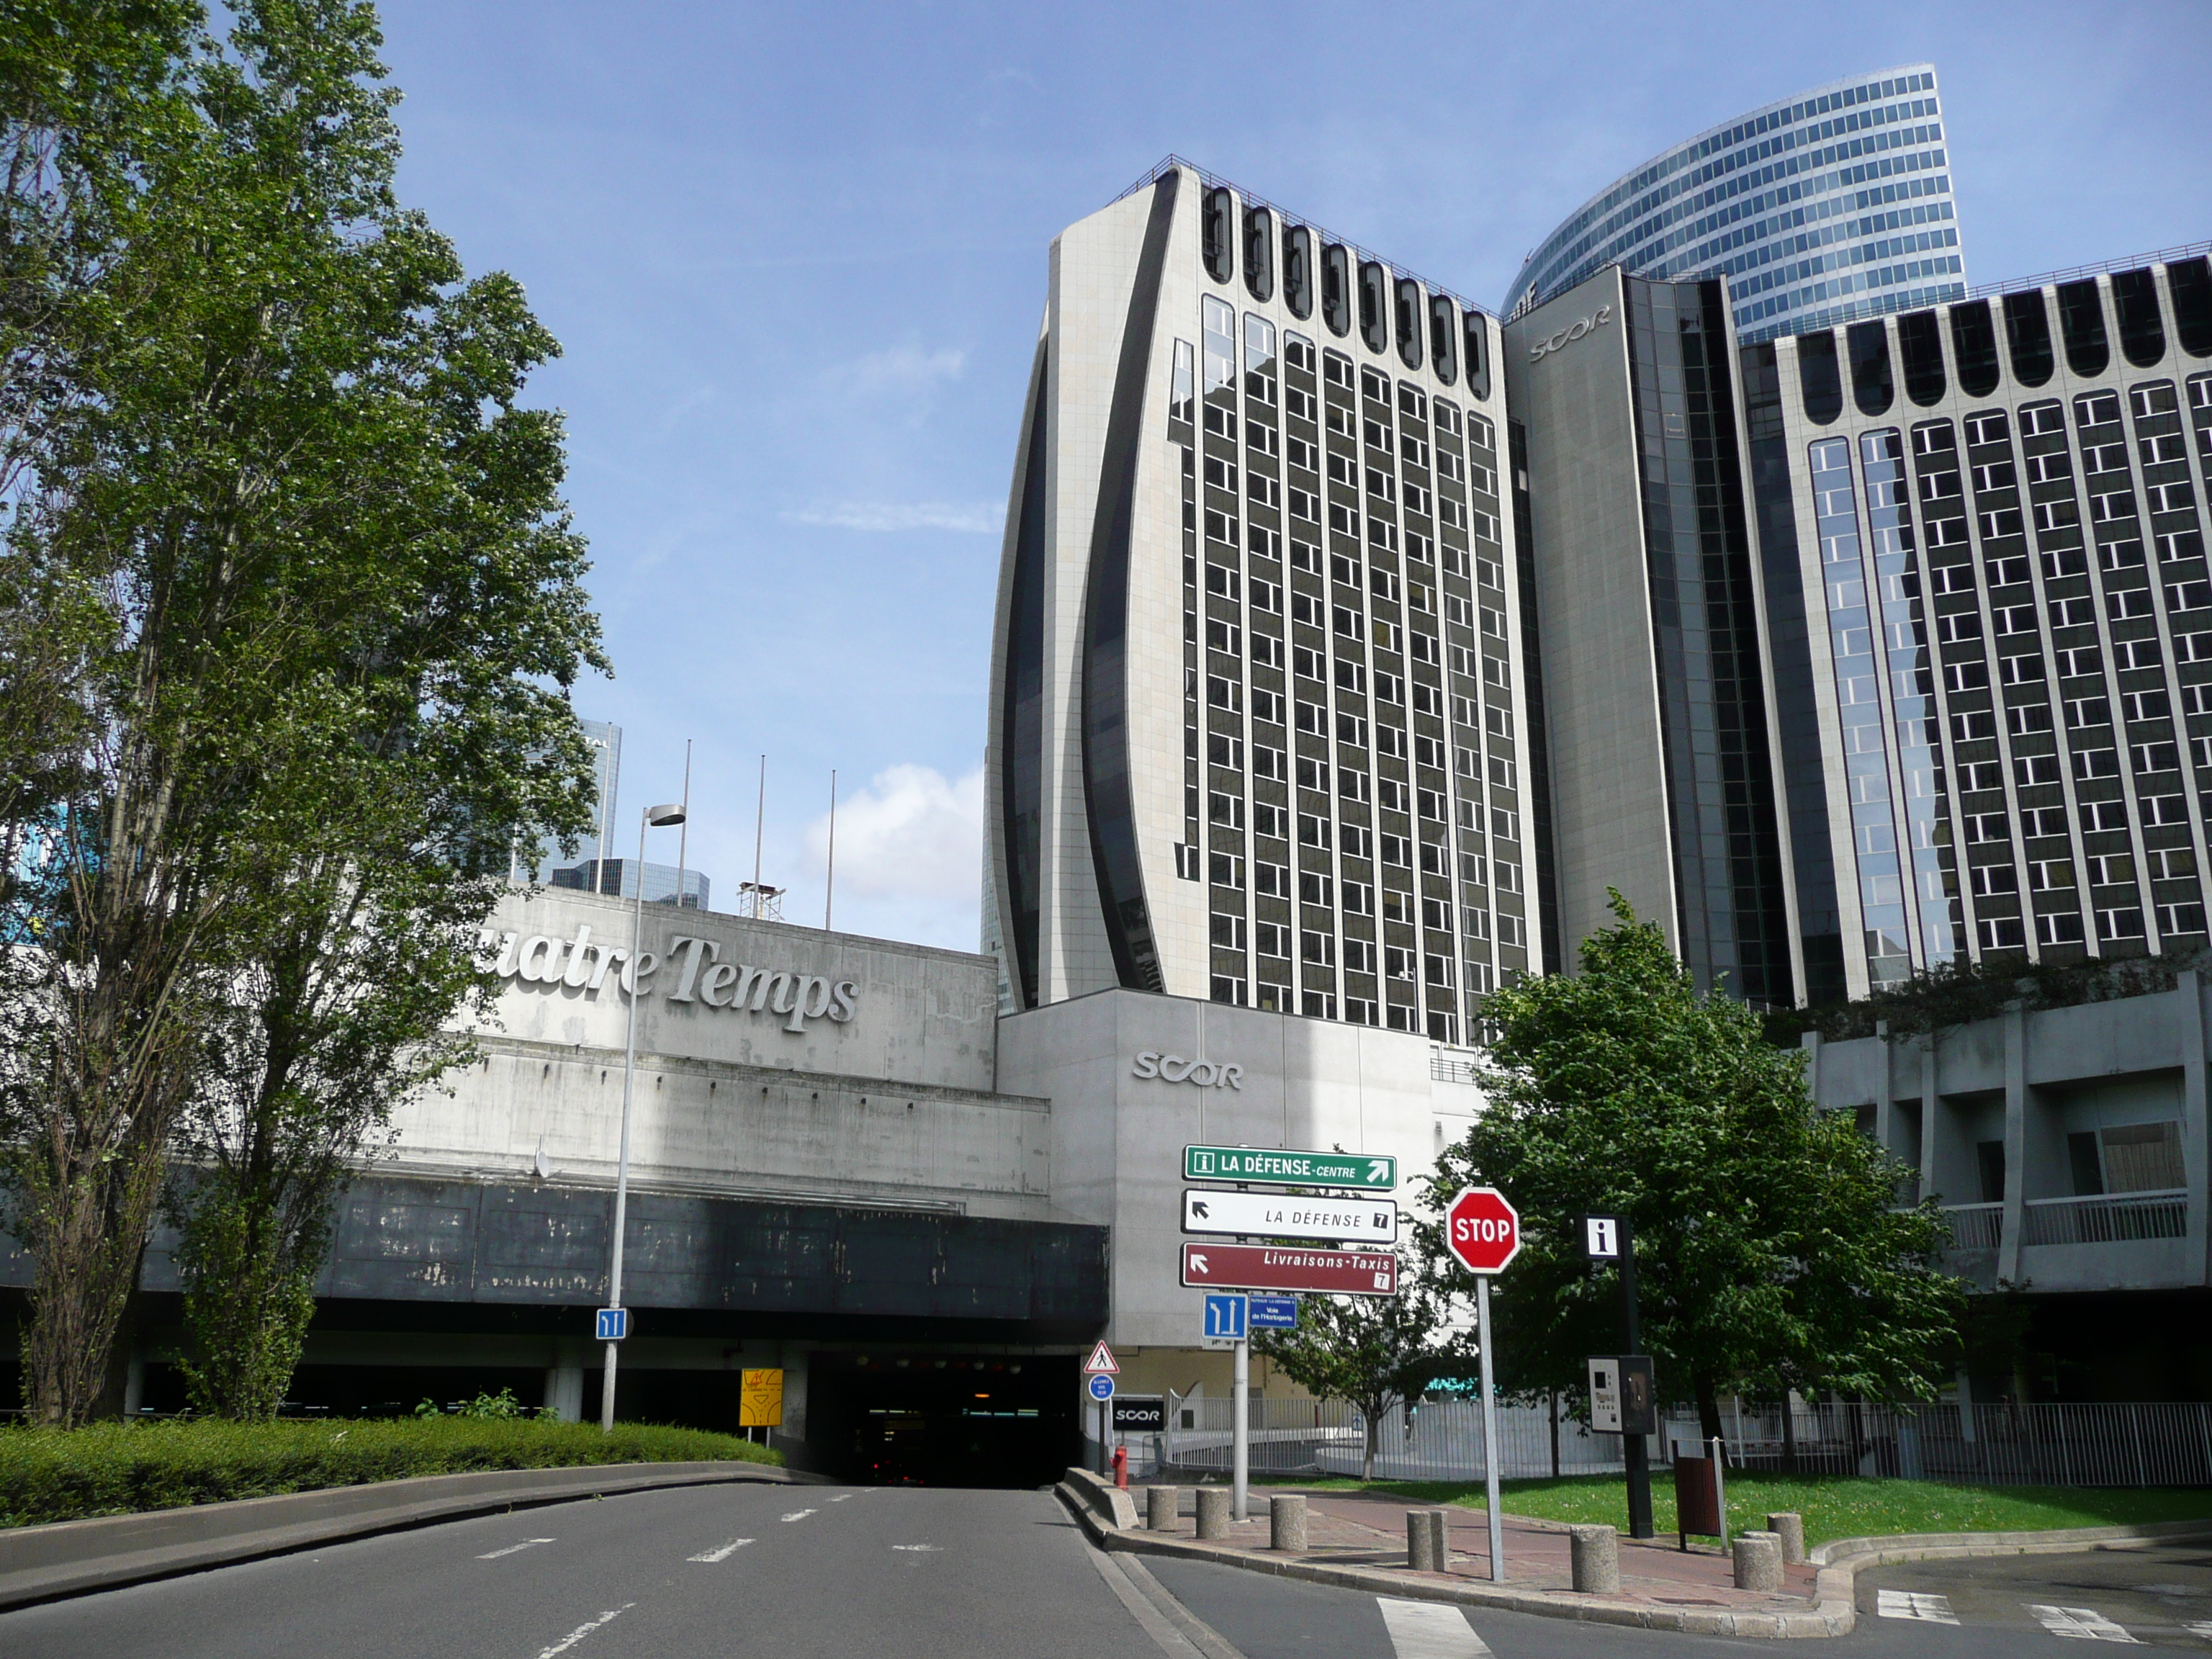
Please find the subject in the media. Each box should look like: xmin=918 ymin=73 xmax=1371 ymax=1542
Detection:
xmin=1128 ymin=1393 xmax=2212 ymax=1486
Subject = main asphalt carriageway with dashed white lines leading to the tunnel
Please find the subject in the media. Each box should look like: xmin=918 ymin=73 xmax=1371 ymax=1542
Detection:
xmin=0 ymin=1484 xmax=1159 ymax=1659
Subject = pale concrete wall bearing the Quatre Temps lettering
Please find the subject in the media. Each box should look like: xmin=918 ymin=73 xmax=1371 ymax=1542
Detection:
xmin=394 ymin=891 xmax=1051 ymax=1221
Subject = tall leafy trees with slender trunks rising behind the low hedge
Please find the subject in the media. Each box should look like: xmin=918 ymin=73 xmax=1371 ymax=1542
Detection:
xmin=0 ymin=0 xmax=606 ymax=1422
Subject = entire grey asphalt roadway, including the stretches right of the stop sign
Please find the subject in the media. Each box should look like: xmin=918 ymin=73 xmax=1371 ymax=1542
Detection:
xmin=0 ymin=1486 xmax=2212 ymax=1659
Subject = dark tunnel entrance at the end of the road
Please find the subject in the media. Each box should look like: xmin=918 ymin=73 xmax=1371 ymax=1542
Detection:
xmin=807 ymin=1352 xmax=1079 ymax=1486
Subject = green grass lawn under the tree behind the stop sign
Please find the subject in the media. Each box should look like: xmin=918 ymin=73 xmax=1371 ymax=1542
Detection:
xmin=1272 ymin=1469 xmax=2212 ymax=1544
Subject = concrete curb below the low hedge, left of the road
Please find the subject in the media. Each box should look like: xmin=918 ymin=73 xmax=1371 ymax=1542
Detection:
xmin=0 ymin=1460 xmax=827 ymax=1610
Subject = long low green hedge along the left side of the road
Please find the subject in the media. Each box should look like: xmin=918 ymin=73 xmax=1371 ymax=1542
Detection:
xmin=0 ymin=1416 xmax=783 ymax=1527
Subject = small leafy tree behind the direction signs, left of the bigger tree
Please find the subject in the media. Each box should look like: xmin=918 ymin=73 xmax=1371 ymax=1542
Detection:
xmin=1252 ymin=1261 xmax=1453 ymax=1480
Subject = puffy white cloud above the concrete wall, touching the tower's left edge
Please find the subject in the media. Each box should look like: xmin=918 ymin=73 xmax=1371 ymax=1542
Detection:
xmin=807 ymin=765 xmax=982 ymax=902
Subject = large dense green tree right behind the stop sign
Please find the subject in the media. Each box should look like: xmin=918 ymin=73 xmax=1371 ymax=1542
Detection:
xmin=1420 ymin=894 xmax=1962 ymax=1436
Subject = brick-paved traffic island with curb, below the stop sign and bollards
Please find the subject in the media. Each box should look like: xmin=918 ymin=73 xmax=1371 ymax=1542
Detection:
xmin=1059 ymin=1471 xmax=2212 ymax=1637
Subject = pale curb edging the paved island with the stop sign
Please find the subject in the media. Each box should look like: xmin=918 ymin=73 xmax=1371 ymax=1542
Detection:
xmin=1053 ymin=1482 xmax=2212 ymax=1639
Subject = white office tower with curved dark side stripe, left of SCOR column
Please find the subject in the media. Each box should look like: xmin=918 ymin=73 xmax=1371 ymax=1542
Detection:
xmin=984 ymin=161 xmax=1546 ymax=1042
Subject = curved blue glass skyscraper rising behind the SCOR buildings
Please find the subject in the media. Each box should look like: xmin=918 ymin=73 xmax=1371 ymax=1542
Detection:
xmin=1506 ymin=64 xmax=1966 ymax=341
